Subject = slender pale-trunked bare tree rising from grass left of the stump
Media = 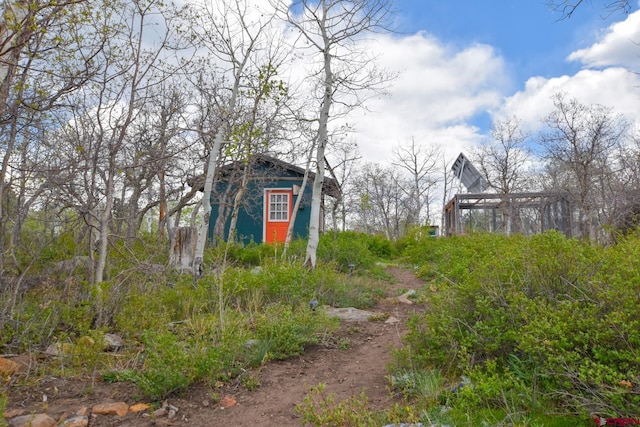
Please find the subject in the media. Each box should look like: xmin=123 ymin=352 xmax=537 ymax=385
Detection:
xmin=39 ymin=0 xmax=181 ymax=285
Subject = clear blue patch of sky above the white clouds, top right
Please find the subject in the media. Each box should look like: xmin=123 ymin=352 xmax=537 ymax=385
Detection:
xmin=397 ymin=0 xmax=624 ymax=82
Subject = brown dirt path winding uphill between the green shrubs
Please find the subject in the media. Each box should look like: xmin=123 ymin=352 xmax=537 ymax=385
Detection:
xmin=206 ymin=268 xmax=423 ymax=427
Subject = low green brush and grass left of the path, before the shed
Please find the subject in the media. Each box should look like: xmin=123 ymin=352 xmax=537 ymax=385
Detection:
xmin=0 ymin=227 xmax=390 ymax=400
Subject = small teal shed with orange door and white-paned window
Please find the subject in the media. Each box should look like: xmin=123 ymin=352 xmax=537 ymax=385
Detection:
xmin=209 ymin=154 xmax=341 ymax=243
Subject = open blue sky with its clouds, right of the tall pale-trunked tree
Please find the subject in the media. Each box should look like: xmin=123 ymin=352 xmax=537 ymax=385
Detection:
xmin=344 ymin=0 xmax=640 ymax=163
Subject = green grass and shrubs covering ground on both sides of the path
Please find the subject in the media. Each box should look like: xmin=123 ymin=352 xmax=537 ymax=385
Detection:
xmin=0 ymin=233 xmax=640 ymax=426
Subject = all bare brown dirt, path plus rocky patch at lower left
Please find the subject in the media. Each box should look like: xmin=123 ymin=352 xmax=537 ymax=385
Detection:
xmin=6 ymin=267 xmax=424 ymax=427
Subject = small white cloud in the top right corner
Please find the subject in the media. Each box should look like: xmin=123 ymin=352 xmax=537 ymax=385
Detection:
xmin=568 ymin=11 xmax=640 ymax=70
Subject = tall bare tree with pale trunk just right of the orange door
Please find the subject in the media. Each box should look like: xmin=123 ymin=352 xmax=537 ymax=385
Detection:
xmin=273 ymin=0 xmax=391 ymax=268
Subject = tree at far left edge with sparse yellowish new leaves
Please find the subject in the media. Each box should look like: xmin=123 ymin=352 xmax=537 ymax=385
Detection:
xmin=0 ymin=0 xmax=102 ymax=265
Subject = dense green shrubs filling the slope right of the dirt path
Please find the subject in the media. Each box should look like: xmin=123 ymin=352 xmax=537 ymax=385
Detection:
xmin=402 ymin=232 xmax=640 ymax=417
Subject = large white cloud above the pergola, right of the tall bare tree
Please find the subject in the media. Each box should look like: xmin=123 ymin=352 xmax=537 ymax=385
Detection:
xmin=349 ymin=33 xmax=509 ymax=163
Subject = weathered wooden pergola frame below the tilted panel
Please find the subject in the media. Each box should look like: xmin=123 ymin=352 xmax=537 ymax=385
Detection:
xmin=444 ymin=192 xmax=573 ymax=237
